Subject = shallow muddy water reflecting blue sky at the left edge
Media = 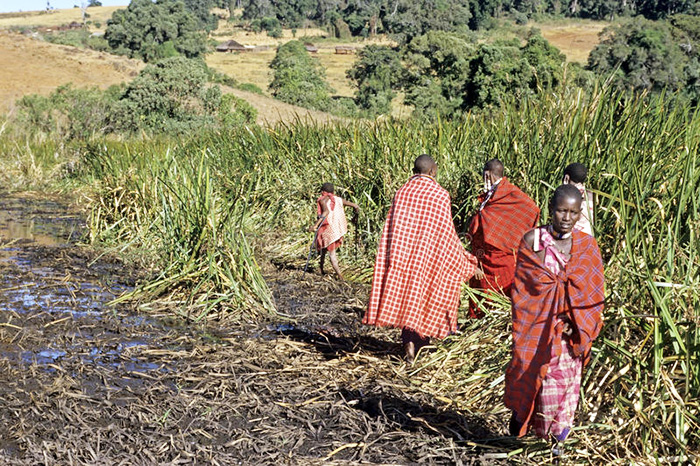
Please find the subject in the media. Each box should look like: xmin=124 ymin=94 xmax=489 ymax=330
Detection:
xmin=0 ymin=195 xmax=166 ymax=372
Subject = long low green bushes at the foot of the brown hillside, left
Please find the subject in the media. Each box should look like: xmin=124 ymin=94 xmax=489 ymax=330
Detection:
xmin=16 ymin=57 xmax=257 ymax=139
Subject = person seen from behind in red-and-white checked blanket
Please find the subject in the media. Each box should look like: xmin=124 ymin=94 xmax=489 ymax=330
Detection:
xmin=362 ymin=154 xmax=476 ymax=362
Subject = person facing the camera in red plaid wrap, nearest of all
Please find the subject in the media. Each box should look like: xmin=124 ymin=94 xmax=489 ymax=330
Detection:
xmin=505 ymin=184 xmax=604 ymax=455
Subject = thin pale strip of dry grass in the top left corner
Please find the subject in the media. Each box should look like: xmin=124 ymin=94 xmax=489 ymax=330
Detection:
xmin=0 ymin=5 xmax=123 ymax=28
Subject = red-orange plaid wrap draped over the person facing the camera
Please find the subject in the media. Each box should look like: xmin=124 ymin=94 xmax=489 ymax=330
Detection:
xmin=504 ymin=231 xmax=605 ymax=435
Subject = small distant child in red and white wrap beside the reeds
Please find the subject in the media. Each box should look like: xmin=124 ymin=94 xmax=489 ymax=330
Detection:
xmin=309 ymin=183 xmax=360 ymax=280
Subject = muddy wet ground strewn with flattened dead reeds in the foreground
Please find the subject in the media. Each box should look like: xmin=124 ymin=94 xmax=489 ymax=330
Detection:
xmin=0 ymin=191 xmax=516 ymax=465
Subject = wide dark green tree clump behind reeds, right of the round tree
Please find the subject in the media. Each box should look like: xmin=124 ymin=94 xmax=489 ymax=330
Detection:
xmin=403 ymin=31 xmax=573 ymax=117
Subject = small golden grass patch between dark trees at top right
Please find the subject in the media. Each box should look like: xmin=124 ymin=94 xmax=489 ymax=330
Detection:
xmin=532 ymin=20 xmax=610 ymax=63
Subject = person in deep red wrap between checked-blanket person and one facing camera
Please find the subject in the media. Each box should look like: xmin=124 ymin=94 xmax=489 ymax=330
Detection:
xmin=469 ymin=159 xmax=540 ymax=317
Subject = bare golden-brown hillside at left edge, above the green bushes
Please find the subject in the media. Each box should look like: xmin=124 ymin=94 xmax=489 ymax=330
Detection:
xmin=0 ymin=31 xmax=144 ymax=111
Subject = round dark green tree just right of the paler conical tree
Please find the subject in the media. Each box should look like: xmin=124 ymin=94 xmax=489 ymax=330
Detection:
xmin=347 ymin=45 xmax=402 ymax=114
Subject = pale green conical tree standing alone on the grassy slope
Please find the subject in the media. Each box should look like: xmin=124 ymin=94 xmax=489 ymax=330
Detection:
xmin=270 ymin=40 xmax=331 ymax=110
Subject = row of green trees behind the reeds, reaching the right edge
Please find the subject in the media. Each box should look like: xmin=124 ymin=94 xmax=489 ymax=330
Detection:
xmin=270 ymin=15 xmax=700 ymax=118
